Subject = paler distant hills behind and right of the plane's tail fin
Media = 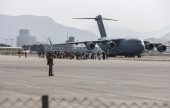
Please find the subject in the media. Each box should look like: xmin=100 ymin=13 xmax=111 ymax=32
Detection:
xmin=87 ymin=25 xmax=170 ymax=40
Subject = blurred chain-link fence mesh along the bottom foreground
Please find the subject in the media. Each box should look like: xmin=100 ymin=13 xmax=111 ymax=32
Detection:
xmin=0 ymin=96 xmax=170 ymax=108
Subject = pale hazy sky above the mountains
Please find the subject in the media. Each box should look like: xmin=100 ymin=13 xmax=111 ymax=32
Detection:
xmin=0 ymin=0 xmax=170 ymax=31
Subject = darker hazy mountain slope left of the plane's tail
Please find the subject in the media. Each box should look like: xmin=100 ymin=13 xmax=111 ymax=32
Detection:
xmin=0 ymin=15 xmax=98 ymax=43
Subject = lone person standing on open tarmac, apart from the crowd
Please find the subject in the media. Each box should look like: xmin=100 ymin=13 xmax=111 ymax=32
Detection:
xmin=47 ymin=52 xmax=54 ymax=76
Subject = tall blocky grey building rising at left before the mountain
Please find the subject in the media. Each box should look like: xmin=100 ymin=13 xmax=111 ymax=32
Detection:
xmin=17 ymin=29 xmax=36 ymax=47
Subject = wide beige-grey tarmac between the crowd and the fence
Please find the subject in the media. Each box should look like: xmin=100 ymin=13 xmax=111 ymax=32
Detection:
xmin=0 ymin=55 xmax=170 ymax=103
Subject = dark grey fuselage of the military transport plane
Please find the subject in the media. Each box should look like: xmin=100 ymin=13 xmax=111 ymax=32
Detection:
xmin=98 ymin=38 xmax=145 ymax=56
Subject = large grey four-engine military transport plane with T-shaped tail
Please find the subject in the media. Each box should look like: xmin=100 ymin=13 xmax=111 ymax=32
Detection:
xmin=58 ymin=15 xmax=167 ymax=57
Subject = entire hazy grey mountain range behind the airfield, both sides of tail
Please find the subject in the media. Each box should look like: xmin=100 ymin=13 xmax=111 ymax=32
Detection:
xmin=0 ymin=15 xmax=170 ymax=43
